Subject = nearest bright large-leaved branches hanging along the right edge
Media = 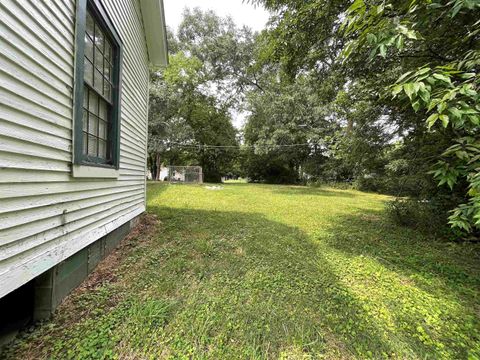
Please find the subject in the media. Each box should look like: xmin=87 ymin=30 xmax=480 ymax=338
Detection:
xmin=343 ymin=0 xmax=480 ymax=234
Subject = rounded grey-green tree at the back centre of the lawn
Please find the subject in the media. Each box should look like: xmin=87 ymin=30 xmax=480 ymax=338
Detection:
xmin=244 ymin=75 xmax=335 ymax=183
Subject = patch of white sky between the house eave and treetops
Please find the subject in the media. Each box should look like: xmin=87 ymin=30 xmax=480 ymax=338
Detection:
xmin=163 ymin=0 xmax=268 ymax=31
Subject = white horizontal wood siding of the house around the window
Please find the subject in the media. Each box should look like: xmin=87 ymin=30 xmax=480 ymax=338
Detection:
xmin=0 ymin=0 xmax=148 ymax=297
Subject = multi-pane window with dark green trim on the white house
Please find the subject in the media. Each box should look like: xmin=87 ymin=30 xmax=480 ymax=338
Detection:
xmin=74 ymin=0 xmax=122 ymax=169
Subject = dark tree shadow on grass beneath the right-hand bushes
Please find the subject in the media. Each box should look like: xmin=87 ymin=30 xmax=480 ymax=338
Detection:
xmin=325 ymin=209 xmax=480 ymax=297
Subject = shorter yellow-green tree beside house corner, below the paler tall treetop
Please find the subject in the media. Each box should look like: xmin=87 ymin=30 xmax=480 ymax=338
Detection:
xmin=149 ymin=52 xmax=237 ymax=182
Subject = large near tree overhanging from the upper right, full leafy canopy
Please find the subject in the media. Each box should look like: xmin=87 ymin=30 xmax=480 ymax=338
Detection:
xmin=254 ymin=0 xmax=480 ymax=233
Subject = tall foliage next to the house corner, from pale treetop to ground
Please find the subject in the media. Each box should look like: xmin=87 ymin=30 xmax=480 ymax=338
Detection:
xmin=148 ymin=9 xmax=246 ymax=182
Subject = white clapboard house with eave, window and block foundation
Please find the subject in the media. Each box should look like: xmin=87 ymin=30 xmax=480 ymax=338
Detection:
xmin=0 ymin=0 xmax=167 ymax=327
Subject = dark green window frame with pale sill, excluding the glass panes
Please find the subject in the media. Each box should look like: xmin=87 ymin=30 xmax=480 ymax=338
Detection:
xmin=73 ymin=0 xmax=123 ymax=172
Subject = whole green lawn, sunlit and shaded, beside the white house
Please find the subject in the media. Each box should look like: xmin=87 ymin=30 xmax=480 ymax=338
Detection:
xmin=6 ymin=183 xmax=480 ymax=359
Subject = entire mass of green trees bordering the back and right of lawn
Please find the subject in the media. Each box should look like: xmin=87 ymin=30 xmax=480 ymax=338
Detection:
xmin=149 ymin=4 xmax=480 ymax=236
